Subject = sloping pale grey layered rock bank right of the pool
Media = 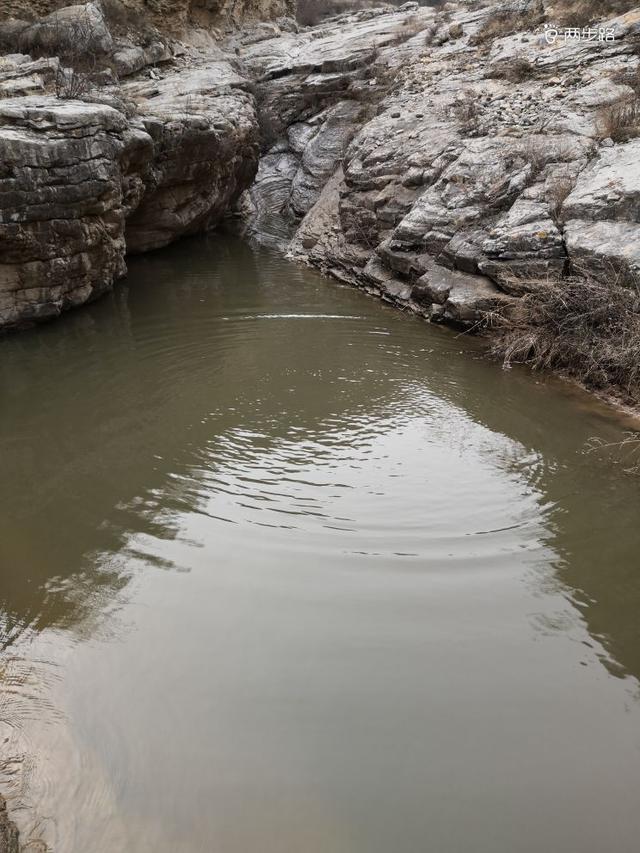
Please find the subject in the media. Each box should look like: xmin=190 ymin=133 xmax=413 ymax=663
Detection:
xmin=236 ymin=0 xmax=640 ymax=324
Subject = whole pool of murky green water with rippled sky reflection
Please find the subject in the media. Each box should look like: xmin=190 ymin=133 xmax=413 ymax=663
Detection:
xmin=0 ymin=236 xmax=640 ymax=853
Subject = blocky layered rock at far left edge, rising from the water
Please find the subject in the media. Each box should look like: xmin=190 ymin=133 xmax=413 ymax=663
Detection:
xmin=0 ymin=97 xmax=128 ymax=326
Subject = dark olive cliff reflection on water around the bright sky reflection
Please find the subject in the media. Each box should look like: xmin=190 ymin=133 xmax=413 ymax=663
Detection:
xmin=0 ymin=236 xmax=640 ymax=677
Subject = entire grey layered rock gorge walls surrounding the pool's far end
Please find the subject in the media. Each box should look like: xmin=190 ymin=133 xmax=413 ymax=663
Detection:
xmin=0 ymin=0 xmax=640 ymax=336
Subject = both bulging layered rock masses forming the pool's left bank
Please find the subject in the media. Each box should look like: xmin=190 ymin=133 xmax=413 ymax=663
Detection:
xmin=0 ymin=30 xmax=259 ymax=327
